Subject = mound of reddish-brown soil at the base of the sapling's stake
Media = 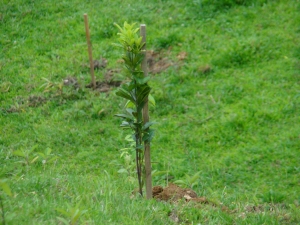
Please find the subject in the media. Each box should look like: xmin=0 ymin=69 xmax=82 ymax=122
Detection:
xmin=152 ymin=183 xmax=209 ymax=204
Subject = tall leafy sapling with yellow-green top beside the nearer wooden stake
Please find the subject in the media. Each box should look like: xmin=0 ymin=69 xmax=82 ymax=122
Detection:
xmin=115 ymin=22 xmax=154 ymax=195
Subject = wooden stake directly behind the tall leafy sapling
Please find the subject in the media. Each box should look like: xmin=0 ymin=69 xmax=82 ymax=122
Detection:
xmin=140 ymin=24 xmax=152 ymax=199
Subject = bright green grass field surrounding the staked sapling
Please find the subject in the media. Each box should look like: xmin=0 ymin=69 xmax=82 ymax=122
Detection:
xmin=0 ymin=0 xmax=300 ymax=225
